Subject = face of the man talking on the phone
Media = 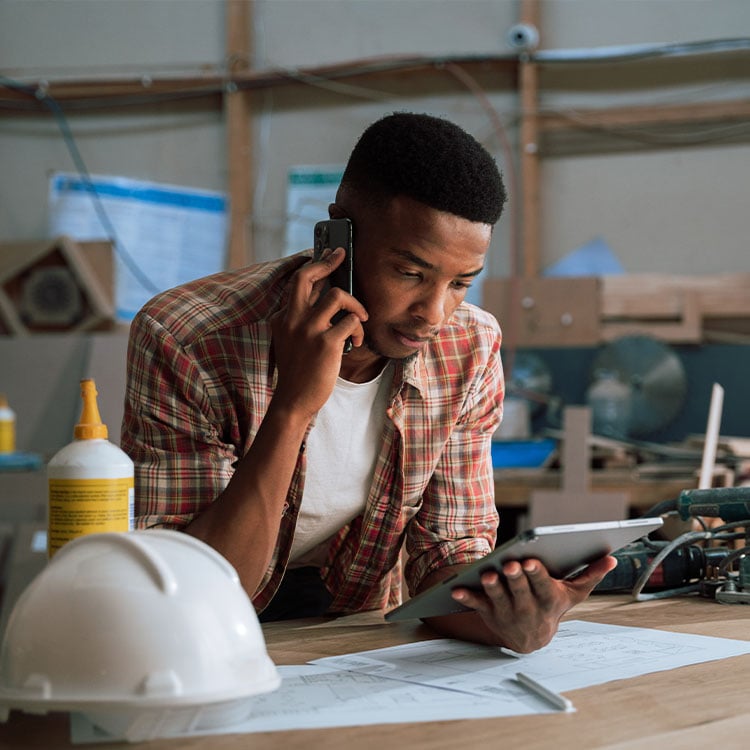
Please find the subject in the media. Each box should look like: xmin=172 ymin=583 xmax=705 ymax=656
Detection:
xmin=349 ymin=197 xmax=492 ymax=359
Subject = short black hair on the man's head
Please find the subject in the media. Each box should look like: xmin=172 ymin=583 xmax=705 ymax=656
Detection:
xmin=339 ymin=112 xmax=507 ymax=224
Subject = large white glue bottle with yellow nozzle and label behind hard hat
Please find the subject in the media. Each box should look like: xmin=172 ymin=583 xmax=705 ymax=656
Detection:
xmin=47 ymin=379 xmax=134 ymax=558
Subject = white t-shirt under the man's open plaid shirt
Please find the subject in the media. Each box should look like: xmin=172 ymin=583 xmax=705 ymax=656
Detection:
xmin=290 ymin=366 xmax=392 ymax=567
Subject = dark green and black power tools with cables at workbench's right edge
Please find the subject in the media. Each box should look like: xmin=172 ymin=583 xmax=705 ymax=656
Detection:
xmin=595 ymin=487 xmax=750 ymax=604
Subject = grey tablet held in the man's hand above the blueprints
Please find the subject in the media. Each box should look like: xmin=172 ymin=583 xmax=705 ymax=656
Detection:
xmin=385 ymin=518 xmax=663 ymax=622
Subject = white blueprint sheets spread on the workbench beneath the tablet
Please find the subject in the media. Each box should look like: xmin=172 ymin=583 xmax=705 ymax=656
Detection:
xmin=71 ymin=620 xmax=750 ymax=744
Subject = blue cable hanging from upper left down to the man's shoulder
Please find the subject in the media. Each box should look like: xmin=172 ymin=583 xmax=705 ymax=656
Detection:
xmin=0 ymin=76 xmax=160 ymax=294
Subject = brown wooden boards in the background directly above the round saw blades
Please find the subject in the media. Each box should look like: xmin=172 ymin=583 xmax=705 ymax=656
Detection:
xmin=482 ymin=273 xmax=750 ymax=348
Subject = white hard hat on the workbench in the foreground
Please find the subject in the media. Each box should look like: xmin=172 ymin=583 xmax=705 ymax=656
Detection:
xmin=0 ymin=530 xmax=281 ymax=741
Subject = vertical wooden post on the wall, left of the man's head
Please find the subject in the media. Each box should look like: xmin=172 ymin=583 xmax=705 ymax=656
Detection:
xmin=224 ymin=0 xmax=254 ymax=269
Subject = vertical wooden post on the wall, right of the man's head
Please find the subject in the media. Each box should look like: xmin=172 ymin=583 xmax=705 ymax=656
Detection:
xmin=518 ymin=0 xmax=539 ymax=278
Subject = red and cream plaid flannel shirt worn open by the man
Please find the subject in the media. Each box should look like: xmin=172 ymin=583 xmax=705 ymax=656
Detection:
xmin=121 ymin=253 xmax=504 ymax=612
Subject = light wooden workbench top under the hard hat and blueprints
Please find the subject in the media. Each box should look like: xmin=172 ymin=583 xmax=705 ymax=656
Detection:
xmin=0 ymin=596 xmax=750 ymax=750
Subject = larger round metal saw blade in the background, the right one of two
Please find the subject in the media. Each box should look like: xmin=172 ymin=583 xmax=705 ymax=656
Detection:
xmin=592 ymin=336 xmax=687 ymax=437
